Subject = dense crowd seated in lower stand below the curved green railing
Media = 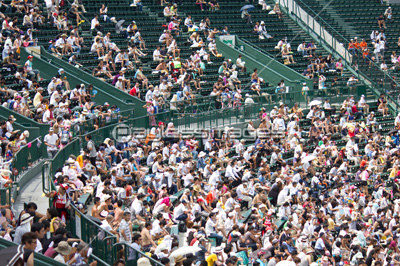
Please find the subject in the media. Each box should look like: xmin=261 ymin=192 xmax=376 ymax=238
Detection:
xmin=0 ymin=91 xmax=400 ymax=266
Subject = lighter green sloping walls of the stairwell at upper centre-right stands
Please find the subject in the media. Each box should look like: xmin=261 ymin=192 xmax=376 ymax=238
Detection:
xmin=216 ymin=37 xmax=313 ymax=93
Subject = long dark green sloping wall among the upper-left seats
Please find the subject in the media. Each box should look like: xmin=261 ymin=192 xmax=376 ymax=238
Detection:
xmin=35 ymin=47 xmax=146 ymax=116
